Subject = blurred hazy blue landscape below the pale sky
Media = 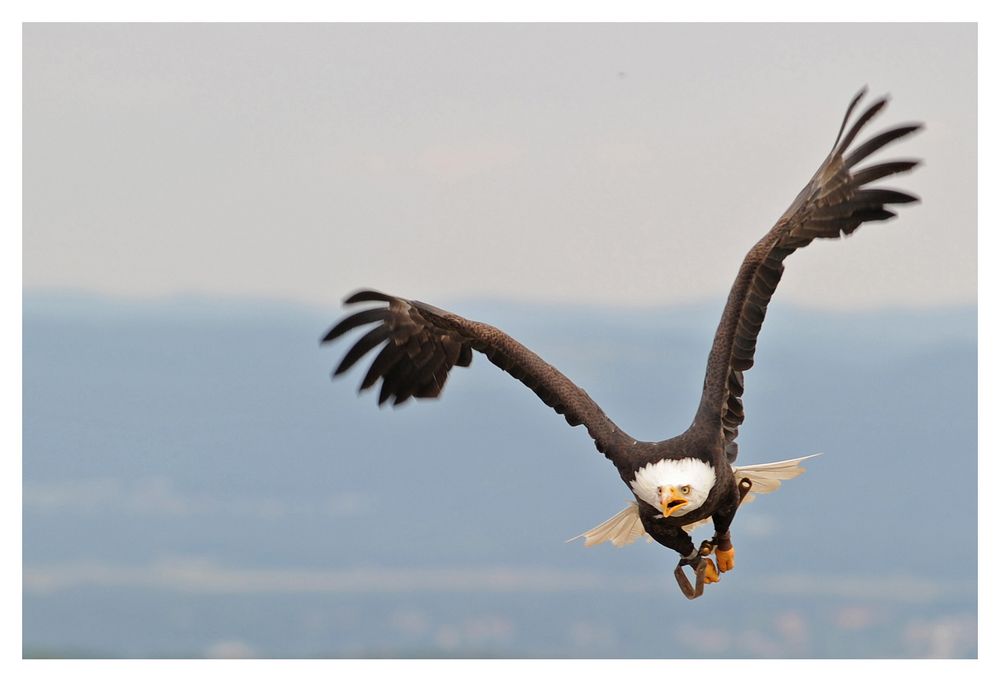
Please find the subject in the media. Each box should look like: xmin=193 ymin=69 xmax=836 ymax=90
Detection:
xmin=23 ymin=292 xmax=977 ymax=657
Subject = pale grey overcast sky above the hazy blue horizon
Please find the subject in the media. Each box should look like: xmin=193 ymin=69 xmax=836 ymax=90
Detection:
xmin=23 ymin=24 xmax=977 ymax=308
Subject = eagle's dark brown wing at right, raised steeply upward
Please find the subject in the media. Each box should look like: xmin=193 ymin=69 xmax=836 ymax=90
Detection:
xmin=695 ymin=89 xmax=921 ymax=462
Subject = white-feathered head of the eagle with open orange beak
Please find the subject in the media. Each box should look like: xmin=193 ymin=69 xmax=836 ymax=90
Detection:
xmin=629 ymin=457 xmax=715 ymax=516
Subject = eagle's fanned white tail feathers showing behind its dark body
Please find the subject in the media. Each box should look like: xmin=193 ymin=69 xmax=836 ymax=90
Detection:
xmin=566 ymin=453 xmax=821 ymax=547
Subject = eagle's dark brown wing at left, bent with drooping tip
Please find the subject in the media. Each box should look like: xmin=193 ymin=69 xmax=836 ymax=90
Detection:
xmin=322 ymin=291 xmax=634 ymax=460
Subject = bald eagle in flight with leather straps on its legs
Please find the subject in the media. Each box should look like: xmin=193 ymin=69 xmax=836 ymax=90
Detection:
xmin=322 ymin=89 xmax=921 ymax=598
